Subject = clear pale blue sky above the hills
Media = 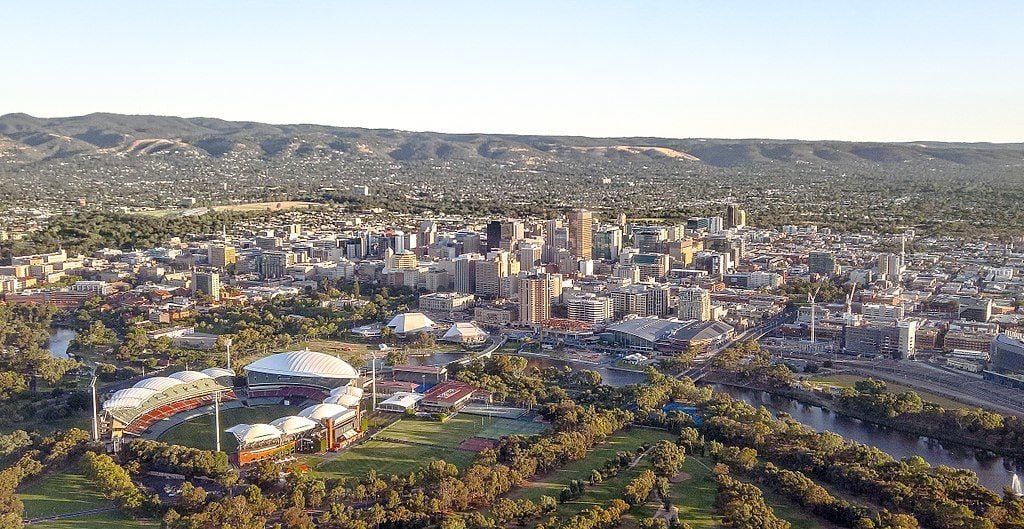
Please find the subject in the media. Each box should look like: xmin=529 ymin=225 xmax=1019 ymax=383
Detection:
xmin=0 ymin=0 xmax=1024 ymax=142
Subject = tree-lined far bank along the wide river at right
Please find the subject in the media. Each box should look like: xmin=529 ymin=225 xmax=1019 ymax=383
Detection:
xmin=701 ymin=372 xmax=1024 ymax=458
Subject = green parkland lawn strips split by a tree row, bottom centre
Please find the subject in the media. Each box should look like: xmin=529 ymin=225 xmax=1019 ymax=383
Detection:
xmin=509 ymin=428 xmax=676 ymax=503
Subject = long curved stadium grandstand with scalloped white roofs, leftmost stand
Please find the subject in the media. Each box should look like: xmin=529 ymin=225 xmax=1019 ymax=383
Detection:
xmin=101 ymin=367 xmax=237 ymax=446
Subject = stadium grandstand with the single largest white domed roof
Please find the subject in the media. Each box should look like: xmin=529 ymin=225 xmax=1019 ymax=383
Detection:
xmin=245 ymin=350 xmax=359 ymax=401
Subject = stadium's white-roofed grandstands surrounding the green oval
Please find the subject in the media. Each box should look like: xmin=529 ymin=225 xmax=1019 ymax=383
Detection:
xmin=100 ymin=350 xmax=364 ymax=465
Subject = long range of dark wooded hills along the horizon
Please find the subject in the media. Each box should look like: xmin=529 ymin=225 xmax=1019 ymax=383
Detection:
xmin=0 ymin=114 xmax=1024 ymax=167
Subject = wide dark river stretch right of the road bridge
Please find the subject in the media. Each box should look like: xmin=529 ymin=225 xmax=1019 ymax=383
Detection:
xmin=712 ymin=384 xmax=1024 ymax=494
